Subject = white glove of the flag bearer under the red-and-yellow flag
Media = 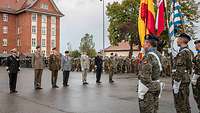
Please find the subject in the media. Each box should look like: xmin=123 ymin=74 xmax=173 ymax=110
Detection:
xmin=138 ymin=80 xmax=149 ymax=99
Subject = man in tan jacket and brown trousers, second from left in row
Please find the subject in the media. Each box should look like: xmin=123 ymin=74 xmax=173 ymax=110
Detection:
xmin=32 ymin=46 xmax=44 ymax=90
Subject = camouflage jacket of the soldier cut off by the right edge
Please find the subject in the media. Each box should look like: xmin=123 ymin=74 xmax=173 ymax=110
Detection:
xmin=192 ymin=53 xmax=200 ymax=75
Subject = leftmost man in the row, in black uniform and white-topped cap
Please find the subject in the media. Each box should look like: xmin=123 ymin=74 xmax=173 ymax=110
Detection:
xmin=6 ymin=49 xmax=20 ymax=94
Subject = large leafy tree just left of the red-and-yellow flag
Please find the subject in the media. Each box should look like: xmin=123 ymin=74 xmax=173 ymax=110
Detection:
xmin=107 ymin=0 xmax=140 ymax=56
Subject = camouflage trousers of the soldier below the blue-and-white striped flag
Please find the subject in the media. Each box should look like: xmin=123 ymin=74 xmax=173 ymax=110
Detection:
xmin=174 ymin=84 xmax=191 ymax=113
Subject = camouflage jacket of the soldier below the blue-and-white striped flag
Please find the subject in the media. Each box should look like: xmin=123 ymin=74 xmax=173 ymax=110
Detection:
xmin=172 ymin=47 xmax=193 ymax=83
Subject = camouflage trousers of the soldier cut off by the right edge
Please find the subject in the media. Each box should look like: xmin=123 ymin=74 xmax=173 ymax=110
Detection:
xmin=192 ymin=81 xmax=200 ymax=112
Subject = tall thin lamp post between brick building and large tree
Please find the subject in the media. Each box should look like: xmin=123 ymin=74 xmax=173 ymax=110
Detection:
xmin=100 ymin=0 xmax=105 ymax=56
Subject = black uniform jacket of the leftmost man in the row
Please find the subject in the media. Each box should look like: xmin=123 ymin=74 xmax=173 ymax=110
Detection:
xmin=6 ymin=55 xmax=20 ymax=73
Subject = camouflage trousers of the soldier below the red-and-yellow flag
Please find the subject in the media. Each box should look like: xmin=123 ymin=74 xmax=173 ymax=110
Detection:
xmin=139 ymin=91 xmax=160 ymax=113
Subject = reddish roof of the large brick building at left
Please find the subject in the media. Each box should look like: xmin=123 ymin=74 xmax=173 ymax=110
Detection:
xmin=0 ymin=0 xmax=64 ymax=16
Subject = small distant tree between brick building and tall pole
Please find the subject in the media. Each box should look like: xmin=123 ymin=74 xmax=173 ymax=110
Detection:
xmin=79 ymin=33 xmax=96 ymax=57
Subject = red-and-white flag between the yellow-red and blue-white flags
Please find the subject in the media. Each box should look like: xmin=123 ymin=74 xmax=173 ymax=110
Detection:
xmin=156 ymin=0 xmax=165 ymax=36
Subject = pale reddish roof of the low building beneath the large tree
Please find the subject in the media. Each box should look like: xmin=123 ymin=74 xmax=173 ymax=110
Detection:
xmin=104 ymin=41 xmax=139 ymax=52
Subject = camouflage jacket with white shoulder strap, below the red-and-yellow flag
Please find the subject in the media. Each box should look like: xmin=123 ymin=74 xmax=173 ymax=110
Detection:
xmin=139 ymin=49 xmax=162 ymax=91
